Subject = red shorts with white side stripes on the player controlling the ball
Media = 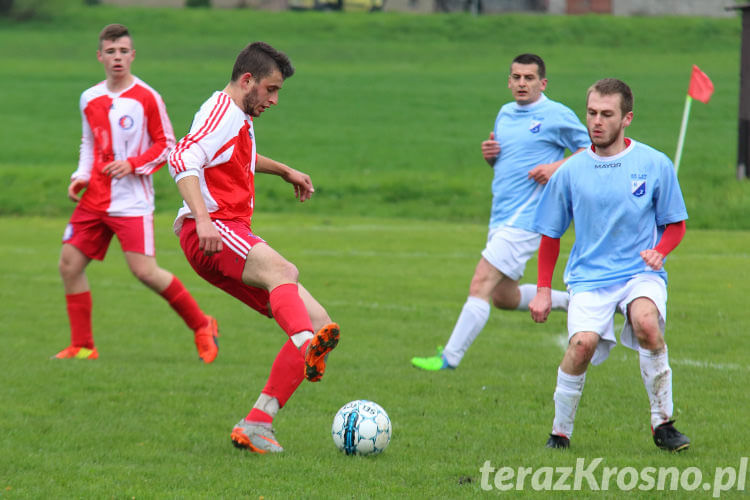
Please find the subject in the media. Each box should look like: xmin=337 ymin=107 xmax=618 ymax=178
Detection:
xmin=180 ymin=218 xmax=271 ymax=318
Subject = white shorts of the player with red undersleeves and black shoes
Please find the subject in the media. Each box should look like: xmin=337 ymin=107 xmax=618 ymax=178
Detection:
xmin=568 ymin=273 xmax=667 ymax=365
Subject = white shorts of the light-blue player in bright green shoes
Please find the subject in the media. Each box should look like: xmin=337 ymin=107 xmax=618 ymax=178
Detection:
xmin=482 ymin=226 xmax=542 ymax=281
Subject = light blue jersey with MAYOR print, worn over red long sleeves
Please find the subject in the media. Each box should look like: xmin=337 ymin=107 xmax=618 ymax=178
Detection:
xmin=534 ymin=139 xmax=687 ymax=293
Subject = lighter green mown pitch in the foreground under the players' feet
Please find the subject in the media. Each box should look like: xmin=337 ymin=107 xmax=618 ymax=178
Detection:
xmin=0 ymin=215 xmax=750 ymax=498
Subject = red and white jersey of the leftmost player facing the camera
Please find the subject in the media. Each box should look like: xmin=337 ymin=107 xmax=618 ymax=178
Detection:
xmin=71 ymin=78 xmax=175 ymax=217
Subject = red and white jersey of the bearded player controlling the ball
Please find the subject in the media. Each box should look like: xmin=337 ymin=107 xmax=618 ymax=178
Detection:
xmin=168 ymin=91 xmax=256 ymax=234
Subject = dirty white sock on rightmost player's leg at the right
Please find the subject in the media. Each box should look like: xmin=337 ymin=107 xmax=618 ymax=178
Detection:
xmin=638 ymin=345 xmax=673 ymax=429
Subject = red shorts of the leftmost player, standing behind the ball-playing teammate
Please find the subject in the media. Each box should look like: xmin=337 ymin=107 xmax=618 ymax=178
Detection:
xmin=62 ymin=205 xmax=155 ymax=260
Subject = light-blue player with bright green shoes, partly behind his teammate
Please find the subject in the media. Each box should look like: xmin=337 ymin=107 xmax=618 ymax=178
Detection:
xmin=412 ymin=54 xmax=589 ymax=370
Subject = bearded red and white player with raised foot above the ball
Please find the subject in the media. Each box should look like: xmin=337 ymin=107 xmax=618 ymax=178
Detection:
xmin=169 ymin=42 xmax=339 ymax=453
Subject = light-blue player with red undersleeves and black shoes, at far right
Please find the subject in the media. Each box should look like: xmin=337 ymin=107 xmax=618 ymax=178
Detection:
xmin=529 ymin=78 xmax=690 ymax=451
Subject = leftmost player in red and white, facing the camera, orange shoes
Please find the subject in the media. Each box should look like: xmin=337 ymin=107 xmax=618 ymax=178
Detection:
xmin=54 ymin=24 xmax=218 ymax=363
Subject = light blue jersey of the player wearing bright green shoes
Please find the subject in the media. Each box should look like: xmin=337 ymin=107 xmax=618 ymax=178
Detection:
xmin=490 ymin=94 xmax=591 ymax=231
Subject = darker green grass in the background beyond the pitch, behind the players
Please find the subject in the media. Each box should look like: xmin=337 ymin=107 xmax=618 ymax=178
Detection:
xmin=0 ymin=1 xmax=750 ymax=229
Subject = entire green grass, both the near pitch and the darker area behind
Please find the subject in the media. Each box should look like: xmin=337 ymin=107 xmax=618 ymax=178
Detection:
xmin=0 ymin=7 xmax=750 ymax=499
